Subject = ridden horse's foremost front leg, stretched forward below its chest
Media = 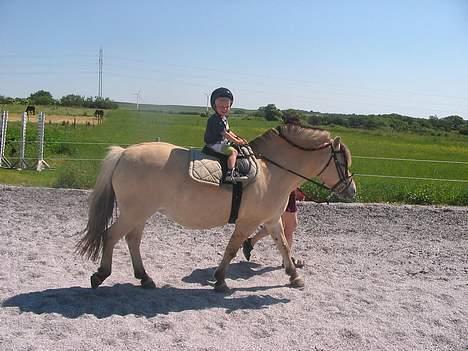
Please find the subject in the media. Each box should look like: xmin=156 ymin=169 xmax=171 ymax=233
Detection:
xmin=265 ymin=219 xmax=304 ymax=288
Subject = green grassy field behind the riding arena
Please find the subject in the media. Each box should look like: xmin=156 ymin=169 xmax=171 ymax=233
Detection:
xmin=0 ymin=109 xmax=468 ymax=206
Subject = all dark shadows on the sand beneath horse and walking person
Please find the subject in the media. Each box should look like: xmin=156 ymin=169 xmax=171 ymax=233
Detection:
xmin=2 ymin=268 xmax=290 ymax=318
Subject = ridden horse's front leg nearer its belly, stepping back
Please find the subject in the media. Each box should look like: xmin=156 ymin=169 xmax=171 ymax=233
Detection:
xmin=214 ymin=223 xmax=259 ymax=293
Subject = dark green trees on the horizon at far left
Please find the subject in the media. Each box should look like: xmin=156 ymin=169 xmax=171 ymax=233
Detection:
xmin=0 ymin=90 xmax=118 ymax=109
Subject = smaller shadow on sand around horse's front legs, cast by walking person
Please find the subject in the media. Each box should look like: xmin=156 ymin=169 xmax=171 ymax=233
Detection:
xmin=182 ymin=262 xmax=282 ymax=285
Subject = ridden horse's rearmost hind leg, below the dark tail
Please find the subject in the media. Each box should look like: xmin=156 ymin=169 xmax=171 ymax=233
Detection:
xmin=91 ymin=218 xmax=133 ymax=289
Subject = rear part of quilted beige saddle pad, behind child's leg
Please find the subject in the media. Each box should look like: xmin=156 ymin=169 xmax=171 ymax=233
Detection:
xmin=189 ymin=149 xmax=223 ymax=186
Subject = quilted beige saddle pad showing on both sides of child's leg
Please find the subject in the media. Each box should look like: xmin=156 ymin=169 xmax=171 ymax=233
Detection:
xmin=189 ymin=145 xmax=258 ymax=187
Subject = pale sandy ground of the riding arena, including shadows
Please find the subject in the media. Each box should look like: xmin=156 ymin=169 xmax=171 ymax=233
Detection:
xmin=0 ymin=185 xmax=468 ymax=351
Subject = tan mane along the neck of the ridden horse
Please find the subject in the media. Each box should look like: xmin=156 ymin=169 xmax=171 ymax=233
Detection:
xmin=249 ymin=124 xmax=330 ymax=152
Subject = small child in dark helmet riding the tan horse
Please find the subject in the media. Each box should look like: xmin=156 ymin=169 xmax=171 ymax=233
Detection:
xmin=204 ymin=87 xmax=247 ymax=183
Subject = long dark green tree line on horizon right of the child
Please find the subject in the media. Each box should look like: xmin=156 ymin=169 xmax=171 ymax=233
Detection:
xmin=255 ymin=104 xmax=468 ymax=135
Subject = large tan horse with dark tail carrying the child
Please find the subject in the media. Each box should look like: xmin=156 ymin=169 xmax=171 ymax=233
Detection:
xmin=76 ymin=125 xmax=356 ymax=292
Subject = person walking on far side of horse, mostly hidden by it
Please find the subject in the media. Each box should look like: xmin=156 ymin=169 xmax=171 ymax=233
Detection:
xmin=242 ymin=115 xmax=305 ymax=268
